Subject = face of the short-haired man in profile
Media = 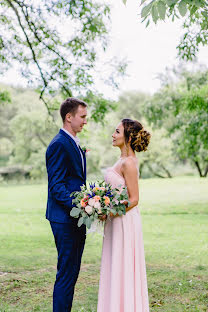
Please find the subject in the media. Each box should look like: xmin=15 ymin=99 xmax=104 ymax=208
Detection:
xmin=70 ymin=105 xmax=87 ymax=133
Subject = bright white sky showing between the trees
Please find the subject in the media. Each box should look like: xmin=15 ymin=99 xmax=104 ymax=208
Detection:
xmin=0 ymin=0 xmax=208 ymax=98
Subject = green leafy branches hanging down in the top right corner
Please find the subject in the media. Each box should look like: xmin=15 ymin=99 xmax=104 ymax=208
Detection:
xmin=123 ymin=0 xmax=208 ymax=60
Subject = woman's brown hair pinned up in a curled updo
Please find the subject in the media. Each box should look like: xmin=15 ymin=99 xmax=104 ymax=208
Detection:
xmin=121 ymin=119 xmax=151 ymax=152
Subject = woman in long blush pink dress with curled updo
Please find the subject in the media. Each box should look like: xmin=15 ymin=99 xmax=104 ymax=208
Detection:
xmin=97 ymin=119 xmax=150 ymax=312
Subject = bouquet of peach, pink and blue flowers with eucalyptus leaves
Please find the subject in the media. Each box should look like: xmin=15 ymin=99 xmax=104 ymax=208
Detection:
xmin=70 ymin=181 xmax=128 ymax=229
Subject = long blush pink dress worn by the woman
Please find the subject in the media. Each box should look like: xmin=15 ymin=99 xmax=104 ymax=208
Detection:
xmin=97 ymin=167 xmax=149 ymax=312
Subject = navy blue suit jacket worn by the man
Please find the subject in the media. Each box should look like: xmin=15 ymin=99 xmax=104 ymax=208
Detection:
xmin=46 ymin=130 xmax=86 ymax=223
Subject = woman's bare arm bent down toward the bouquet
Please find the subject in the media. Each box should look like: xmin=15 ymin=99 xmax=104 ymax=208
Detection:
xmin=121 ymin=158 xmax=139 ymax=211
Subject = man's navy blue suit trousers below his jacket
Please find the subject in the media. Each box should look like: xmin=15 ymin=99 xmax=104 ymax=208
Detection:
xmin=50 ymin=219 xmax=86 ymax=312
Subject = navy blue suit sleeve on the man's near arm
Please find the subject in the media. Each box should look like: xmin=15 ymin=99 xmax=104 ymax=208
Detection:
xmin=46 ymin=142 xmax=73 ymax=209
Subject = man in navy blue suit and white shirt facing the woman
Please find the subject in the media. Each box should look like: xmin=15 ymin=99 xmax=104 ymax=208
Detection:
xmin=46 ymin=98 xmax=87 ymax=312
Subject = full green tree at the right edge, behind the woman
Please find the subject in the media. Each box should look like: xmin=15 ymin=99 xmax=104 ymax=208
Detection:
xmin=146 ymin=71 xmax=208 ymax=177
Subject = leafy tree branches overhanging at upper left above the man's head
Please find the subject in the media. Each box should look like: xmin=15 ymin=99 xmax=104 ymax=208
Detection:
xmin=0 ymin=0 xmax=125 ymax=119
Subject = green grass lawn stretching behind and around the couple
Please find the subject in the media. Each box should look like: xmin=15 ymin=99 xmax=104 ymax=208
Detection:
xmin=0 ymin=177 xmax=208 ymax=312
